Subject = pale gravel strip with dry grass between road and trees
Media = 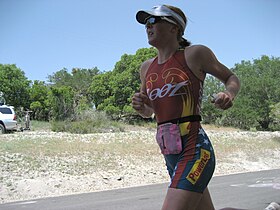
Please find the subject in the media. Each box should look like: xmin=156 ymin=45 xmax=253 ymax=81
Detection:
xmin=0 ymin=129 xmax=280 ymax=203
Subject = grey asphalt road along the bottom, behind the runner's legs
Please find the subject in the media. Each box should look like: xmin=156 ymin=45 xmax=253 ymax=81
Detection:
xmin=0 ymin=169 xmax=280 ymax=210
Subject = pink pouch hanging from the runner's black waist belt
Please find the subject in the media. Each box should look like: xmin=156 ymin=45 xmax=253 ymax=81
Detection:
xmin=156 ymin=123 xmax=182 ymax=155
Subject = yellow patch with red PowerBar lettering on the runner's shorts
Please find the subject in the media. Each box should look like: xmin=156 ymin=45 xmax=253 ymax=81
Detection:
xmin=186 ymin=149 xmax=210 ymax=184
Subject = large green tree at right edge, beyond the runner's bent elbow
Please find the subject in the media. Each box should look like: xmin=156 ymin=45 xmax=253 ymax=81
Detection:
xmin=224 ymin=56 xmax=280 ymax=130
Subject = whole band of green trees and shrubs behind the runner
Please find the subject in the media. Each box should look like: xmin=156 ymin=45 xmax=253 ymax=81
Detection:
xmin=0 ymin=48 xmax=280 ymax=133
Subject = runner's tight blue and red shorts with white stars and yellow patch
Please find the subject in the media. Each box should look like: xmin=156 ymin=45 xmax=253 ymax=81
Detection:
xmin=164 ymin=125 xmax=215 ymax=193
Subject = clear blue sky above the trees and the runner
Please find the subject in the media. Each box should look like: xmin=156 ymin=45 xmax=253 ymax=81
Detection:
xmin=0 ymin=0 xmax=280 ymax=80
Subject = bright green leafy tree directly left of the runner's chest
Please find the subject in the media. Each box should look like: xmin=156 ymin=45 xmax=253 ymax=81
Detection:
xmin=90 ymin=48 xmax=156 ymax=118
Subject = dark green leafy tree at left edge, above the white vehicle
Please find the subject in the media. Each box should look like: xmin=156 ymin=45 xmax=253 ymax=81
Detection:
xmin=0 ymin=64 xmax=30 ymax=108
